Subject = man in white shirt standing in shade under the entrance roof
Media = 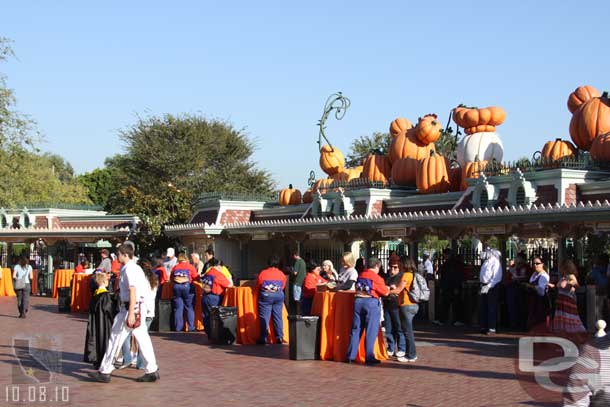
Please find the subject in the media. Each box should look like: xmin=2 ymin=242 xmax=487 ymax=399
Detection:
xmin=479 ymin=247 xmax=502 ymax=335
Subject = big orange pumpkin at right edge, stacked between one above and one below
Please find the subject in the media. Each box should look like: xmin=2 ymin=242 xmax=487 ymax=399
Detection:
xmin=570 ymin=92 xmax=610 ymax=151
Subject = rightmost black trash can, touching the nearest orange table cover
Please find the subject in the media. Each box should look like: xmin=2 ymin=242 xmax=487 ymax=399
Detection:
xmin=288 ymin=315 xmax=320 ymax=360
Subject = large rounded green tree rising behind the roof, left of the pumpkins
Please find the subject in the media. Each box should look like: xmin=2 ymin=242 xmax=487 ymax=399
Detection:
xmin=106 ymin=114 xmax=274 ymax=249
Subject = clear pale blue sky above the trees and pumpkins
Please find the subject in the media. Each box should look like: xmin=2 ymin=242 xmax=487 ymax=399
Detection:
xmin=0 ymin=0 xmax=610 ymax=188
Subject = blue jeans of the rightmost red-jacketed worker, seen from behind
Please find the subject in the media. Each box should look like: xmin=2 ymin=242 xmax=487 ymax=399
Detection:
xmin=347 ymin=297 xmax=381 ymax=361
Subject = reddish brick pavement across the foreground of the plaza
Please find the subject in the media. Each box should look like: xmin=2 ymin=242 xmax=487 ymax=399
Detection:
xmin=0 ymin=297 xmax=553 ymax=407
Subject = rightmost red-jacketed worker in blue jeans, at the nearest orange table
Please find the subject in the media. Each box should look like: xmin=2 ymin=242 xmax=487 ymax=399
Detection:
xmin=347 ymin=257 xmax=390 ymax=365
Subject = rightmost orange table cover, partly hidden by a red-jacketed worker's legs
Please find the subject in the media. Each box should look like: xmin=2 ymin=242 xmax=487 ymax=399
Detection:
xmin=311 ymin=291 xmax=388 ymax=362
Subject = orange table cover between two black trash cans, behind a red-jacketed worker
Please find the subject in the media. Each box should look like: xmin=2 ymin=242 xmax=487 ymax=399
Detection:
xmin=222 ymin=286 xmax=289 ymax=345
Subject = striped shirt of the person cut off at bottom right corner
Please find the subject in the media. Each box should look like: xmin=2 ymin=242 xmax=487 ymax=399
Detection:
xmin=563 ymin=335 xmax=610 ymax=407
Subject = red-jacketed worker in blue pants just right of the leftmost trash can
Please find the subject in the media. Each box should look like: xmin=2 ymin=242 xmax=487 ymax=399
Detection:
xmin=170 ymin=253 xmax=199 ymax=332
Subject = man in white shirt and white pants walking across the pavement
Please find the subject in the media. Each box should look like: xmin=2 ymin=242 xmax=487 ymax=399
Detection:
xmin=89 ymin=244 xmax=160 ymax=383
